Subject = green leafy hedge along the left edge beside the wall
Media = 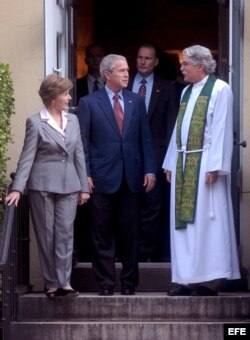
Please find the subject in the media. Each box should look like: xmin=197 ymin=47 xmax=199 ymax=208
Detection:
xmin=0 ymin=63 xmax=15 ymax=221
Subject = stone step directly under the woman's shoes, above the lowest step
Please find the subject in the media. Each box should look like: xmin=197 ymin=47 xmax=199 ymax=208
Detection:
xmin=18 ymin=293 xmax=250 ymax=322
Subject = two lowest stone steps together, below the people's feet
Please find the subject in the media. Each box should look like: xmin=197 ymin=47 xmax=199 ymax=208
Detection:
xmin=11 ymin=292 xmax=250 ymax=340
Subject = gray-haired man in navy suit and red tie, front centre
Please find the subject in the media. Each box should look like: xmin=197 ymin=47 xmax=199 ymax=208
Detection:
xmin=79 ymin=54 xmax=155 ymax=295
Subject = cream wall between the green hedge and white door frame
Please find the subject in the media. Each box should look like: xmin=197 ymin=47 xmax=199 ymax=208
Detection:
xmin=0 ymin=0 xmax=44 ymax=171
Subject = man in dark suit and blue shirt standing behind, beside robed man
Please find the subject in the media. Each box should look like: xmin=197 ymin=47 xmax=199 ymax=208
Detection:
xmin=128 ymin=43 xmax=177 ymax=262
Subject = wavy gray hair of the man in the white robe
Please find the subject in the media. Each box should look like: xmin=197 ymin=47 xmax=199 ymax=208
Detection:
xmin=183 ymin=45 xmax=216 ymax=74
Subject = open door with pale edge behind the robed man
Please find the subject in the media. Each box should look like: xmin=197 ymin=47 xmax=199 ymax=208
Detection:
xmin=218 ymin=0 xmax=243 ymax=243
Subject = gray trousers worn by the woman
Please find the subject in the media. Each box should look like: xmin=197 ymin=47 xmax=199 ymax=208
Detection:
xmin=29 ymin=190 xmax=78 ymax=289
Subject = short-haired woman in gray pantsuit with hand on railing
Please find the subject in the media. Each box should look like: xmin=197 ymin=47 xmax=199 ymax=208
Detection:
xmin=5 ymin=74 xmax=89 ymax=298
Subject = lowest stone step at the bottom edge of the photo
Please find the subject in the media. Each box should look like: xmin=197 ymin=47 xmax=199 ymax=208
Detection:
xmin=11 ymin=321 xmax=248 ymax=340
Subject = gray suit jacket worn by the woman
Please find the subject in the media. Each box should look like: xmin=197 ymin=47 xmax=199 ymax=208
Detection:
xmin=11 ymin=113 xmax=89 ymax=194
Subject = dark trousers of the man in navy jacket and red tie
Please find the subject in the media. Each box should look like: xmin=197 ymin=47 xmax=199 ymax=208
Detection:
xmin=90 ymin=180 xmax=138 ymax=289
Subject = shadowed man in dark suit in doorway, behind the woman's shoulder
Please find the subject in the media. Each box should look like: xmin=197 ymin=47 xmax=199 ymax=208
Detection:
xmin=76 ymin=43 xmax=104 ymax=103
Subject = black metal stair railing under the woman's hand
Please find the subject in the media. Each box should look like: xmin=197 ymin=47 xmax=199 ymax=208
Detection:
xmin=0 ymin=195 xmax=31 ymax=340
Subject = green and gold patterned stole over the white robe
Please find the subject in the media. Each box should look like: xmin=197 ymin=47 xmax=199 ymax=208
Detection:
xmin=175 ymin=75 xmax=216 ymax=229
